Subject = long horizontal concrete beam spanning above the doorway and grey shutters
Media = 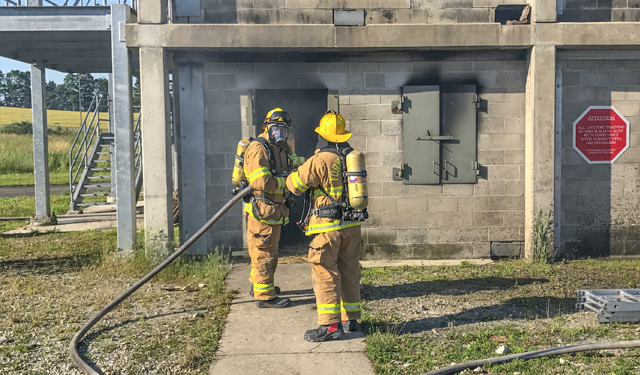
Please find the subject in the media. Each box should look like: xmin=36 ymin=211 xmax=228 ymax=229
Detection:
xmin=127 ymin=23 xmax=533 ymax=50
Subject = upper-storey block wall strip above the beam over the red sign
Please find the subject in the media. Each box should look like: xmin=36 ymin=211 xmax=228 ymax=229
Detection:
xmin=558 ymin=0 xmax=640 ymax=22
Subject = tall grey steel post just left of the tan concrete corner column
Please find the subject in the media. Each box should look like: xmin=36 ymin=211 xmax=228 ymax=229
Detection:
xmin=111 ymin=4 xmax=136 ymax=251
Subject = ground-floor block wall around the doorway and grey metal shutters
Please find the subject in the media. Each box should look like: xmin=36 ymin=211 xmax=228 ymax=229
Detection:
xmin=204 ymin=54 xmax=526 ymax=259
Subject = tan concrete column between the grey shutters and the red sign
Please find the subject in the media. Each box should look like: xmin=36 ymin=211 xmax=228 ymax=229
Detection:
xmin=524 ymin=45 xmax=556 ymax=260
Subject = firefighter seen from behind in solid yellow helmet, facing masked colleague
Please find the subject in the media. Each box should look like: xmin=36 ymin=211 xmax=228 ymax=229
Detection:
xmin=287 ymin=111 xmax=368 ymax=342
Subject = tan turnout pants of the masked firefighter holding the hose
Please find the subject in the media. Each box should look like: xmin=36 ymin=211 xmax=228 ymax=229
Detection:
xmin=246 ymin=215 xmax=281 ymax=301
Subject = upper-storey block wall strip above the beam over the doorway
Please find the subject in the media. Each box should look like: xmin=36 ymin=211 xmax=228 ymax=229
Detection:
xmin=195 ymin=0 xmax=531 ymax=24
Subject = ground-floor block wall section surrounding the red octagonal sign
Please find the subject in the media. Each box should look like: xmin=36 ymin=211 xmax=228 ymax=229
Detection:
xmin=558 ymin=57 xmax=640 ymax=256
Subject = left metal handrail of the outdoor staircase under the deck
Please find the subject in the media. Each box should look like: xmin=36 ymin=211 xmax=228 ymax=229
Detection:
xmin=69 ymin=91 xmax=109 ymax=200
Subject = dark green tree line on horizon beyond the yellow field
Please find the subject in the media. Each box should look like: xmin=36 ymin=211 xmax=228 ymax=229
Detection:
xmin=0 ymin=70 xmax=140 ymax=111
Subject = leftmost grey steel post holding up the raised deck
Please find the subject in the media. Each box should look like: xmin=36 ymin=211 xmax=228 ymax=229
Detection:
xmin=31 ymin=62 xmax=55 ymax=225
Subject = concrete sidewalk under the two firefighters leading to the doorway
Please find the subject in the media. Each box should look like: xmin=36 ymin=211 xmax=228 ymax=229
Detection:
xmin=209 ymin=264 xmax=375 ymax=375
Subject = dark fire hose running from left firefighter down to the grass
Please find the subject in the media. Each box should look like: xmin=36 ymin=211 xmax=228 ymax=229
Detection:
xmin=69 ymin=186 xmax=253 ymax=375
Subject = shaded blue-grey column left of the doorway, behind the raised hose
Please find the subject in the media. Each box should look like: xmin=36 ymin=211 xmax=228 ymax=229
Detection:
xmin=174 ymin=64 xmax=209 ymax=255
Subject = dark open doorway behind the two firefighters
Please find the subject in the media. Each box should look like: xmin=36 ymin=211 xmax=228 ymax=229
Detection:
xmin=254 ymin=89 xmax=328 ymax=252
